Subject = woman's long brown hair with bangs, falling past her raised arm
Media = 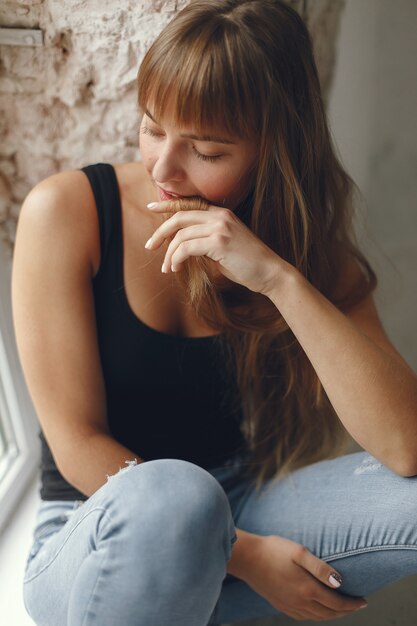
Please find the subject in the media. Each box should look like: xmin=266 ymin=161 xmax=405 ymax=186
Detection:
xmin=138 ymin=0 xmax=376 ymax=487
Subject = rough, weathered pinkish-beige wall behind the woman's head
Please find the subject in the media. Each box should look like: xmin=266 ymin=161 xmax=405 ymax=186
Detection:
xmin=0 ymin=0 xmax=344 ymax=248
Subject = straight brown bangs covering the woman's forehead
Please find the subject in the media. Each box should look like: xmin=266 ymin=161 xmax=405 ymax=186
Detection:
xmin=138 ymin=18 xmax=259 ymax=138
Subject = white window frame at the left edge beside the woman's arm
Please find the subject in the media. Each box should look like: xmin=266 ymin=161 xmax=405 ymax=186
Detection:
xmin=0 ymin=239 xmax=40 ymax=534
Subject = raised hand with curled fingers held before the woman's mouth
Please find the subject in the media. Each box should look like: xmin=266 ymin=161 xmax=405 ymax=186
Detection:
xmin=146 ymin=201 xmax=283 ymax=294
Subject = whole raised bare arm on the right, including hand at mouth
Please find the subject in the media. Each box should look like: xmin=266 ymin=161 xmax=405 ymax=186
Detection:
xmin=147 ymin=201 xmax=417 ymax=476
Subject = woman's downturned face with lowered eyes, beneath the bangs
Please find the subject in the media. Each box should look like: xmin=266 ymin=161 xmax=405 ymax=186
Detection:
xmin=140 ymin=101 xmax=258 ymax=209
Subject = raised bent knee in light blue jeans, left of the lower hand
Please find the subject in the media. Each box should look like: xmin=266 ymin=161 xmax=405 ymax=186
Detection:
xmin=24 ymin=459 xmax=235 ymax=626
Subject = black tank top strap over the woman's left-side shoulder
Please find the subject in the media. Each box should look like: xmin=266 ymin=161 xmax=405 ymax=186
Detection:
xmin=81 ymin=163 xmax=122 ymax=273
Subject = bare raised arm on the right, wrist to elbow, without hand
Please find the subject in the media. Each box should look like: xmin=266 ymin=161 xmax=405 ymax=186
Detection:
xmin=268 ymin=259 xmax=417 ymax=476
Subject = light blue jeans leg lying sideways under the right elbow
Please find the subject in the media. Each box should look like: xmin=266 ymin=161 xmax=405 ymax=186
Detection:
xmin=210 ymin=452 xmax=417 ymax=623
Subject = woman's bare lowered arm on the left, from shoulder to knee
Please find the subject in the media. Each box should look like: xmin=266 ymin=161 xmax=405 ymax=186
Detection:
xmin=12 ymin=172 xmax=145 ymax=496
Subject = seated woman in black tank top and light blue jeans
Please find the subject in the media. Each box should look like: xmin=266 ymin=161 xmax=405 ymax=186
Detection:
xmin=13 ymin=0 xmax=417 ymax=626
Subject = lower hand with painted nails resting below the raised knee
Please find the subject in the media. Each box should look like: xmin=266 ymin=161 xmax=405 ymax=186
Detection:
xmin=239 ymin=535 xmax=366 ymax=621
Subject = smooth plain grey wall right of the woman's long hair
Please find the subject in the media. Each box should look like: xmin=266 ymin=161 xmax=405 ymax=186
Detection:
xmin=329 ymin=0 xmax=417 ymax=370
